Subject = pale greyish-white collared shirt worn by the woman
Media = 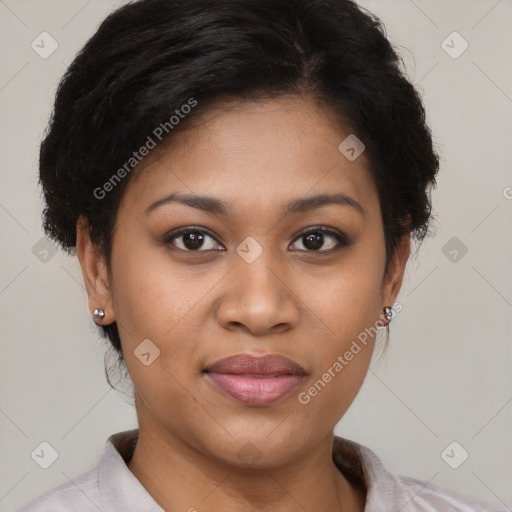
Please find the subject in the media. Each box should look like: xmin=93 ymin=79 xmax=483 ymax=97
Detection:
xmin=13 ymin=429 xmax=508 ymax=512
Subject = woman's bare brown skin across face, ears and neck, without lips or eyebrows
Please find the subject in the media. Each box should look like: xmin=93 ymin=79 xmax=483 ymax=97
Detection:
xmin=77 ymin=96 xmax=409 ymax=512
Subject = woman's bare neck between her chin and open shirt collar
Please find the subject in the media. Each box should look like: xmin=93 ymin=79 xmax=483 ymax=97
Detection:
xmin=128 ymin=428 xmax=365 ymax=512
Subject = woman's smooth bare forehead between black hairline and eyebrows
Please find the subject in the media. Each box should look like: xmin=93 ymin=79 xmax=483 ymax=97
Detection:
xmin=121 ymin=96 xmax=378 ymax=215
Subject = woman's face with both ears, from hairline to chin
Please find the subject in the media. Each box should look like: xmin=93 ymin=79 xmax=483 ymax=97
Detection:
xmin=79 ymin=97 xmax=408 ymax=467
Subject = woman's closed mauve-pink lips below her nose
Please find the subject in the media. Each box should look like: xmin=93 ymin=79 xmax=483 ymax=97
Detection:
xmin=203 ymin=354 xmax=306 ymax=406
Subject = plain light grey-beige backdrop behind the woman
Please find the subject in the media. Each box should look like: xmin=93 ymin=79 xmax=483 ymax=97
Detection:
xmin=0 ymin=0 xmax=512 ymax=511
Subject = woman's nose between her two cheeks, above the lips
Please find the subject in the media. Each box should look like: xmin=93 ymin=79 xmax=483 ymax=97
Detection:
xmin=216 ymin=250 xmax=300 ymax=336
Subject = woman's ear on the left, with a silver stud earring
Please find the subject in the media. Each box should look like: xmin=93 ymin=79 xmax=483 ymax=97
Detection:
xmin=76 ymin=217 xmax=115 ymax=325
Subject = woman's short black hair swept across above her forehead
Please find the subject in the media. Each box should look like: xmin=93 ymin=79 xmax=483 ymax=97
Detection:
xmin=40 ymin=0 xmax=439 ymax=378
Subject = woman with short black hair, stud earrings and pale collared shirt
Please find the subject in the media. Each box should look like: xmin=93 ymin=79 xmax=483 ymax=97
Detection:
xmin=14 ymin=0 xmax=506 ymax=512
